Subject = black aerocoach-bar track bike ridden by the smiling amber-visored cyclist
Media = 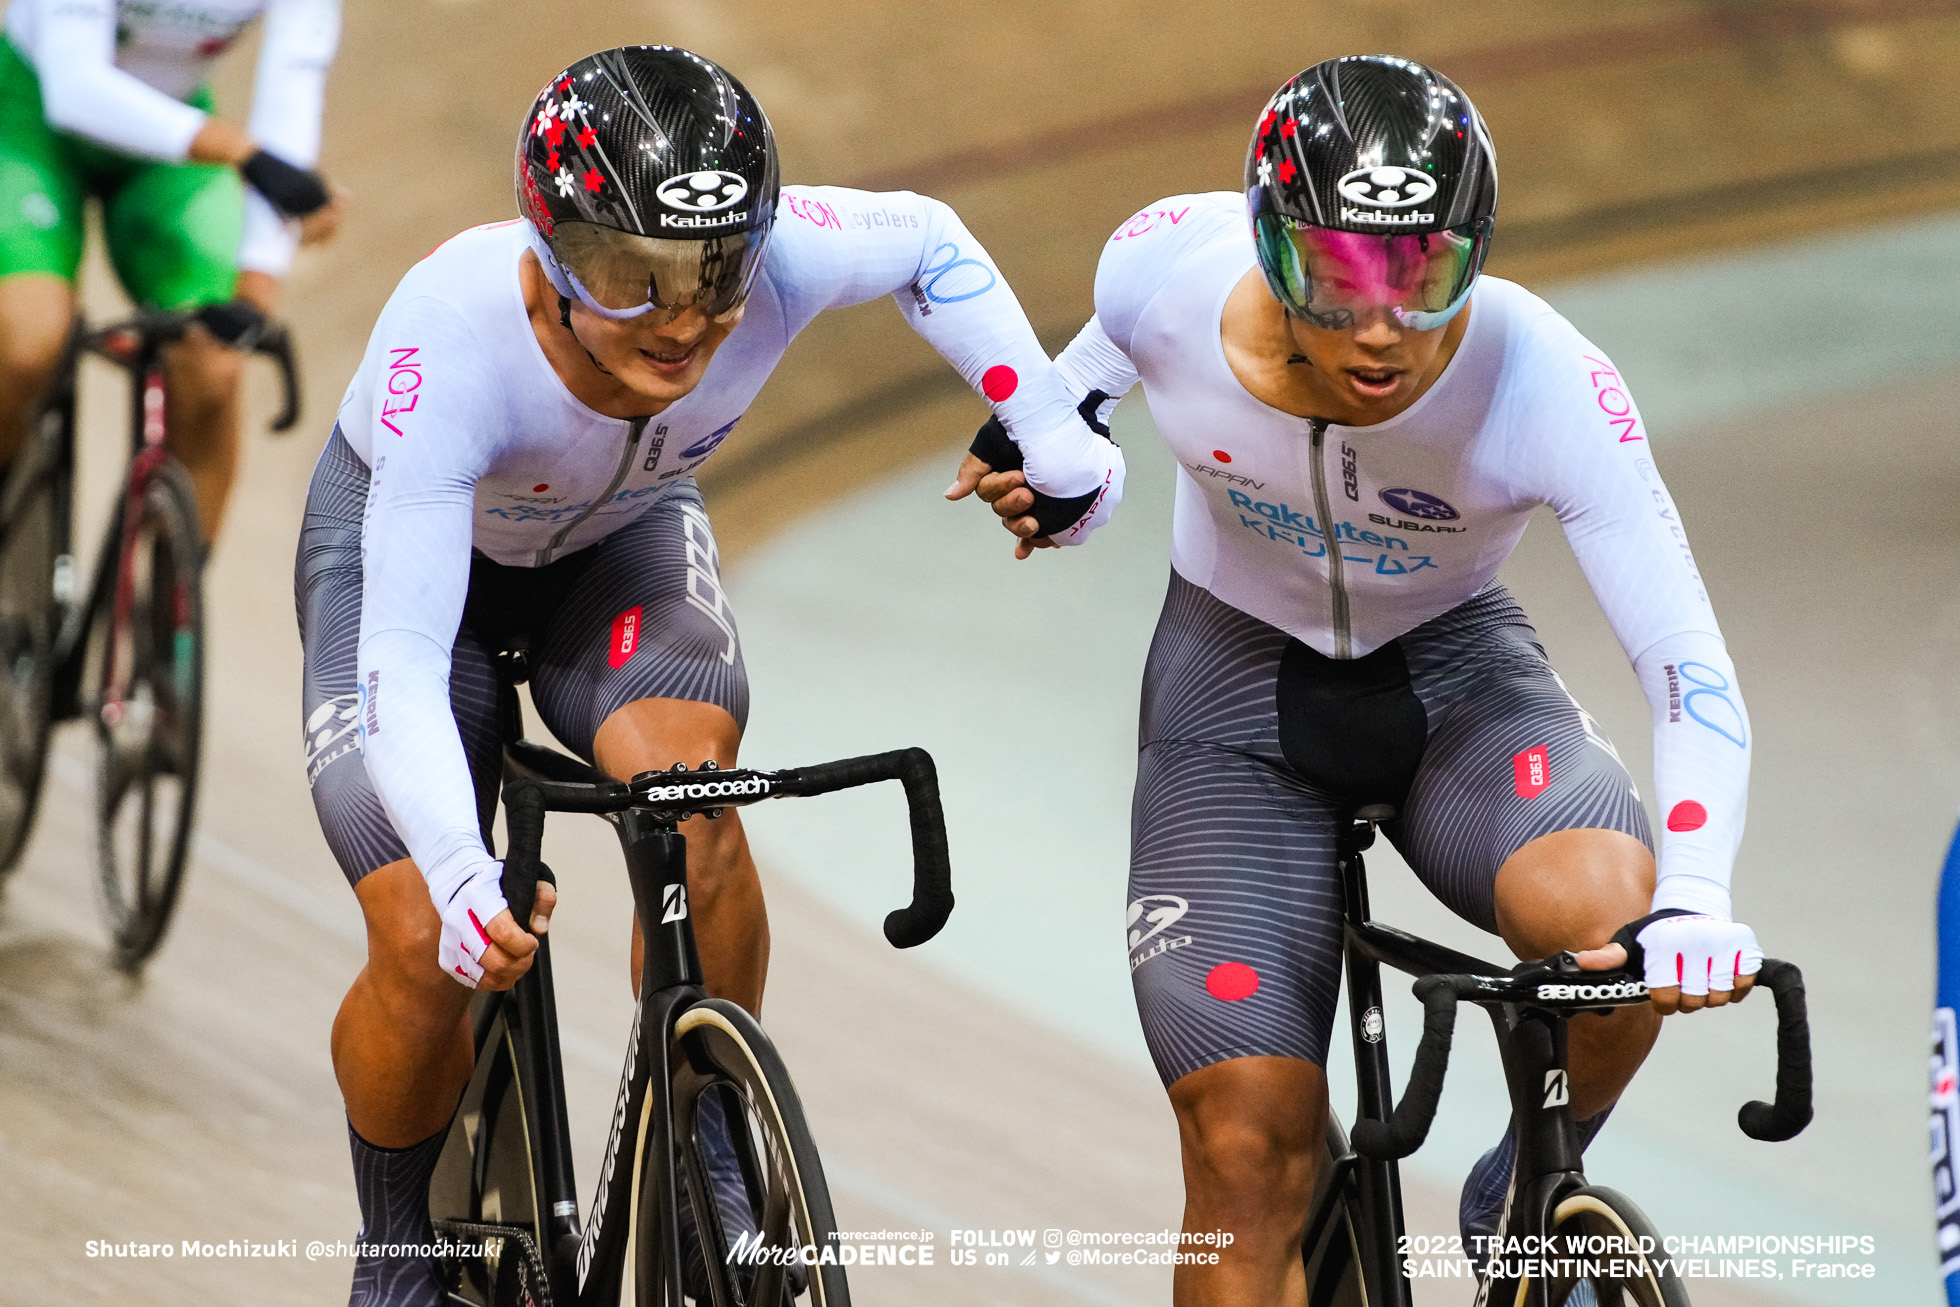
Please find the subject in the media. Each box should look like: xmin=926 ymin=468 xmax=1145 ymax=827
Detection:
xmin=429 ymin=664 xmax=953 ymax=1307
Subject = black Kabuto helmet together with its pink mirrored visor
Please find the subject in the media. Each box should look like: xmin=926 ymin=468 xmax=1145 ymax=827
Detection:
xmin=1245 ymin=55 xmax=1497 ymax=331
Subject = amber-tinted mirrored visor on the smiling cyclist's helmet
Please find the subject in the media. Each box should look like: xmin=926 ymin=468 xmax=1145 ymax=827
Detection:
xmin=551 ymin=221 xmax=768 ymax=317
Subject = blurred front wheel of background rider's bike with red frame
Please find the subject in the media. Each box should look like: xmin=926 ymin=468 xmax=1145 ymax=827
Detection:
xmin=90 ymin=459 xmax=204 ymax=972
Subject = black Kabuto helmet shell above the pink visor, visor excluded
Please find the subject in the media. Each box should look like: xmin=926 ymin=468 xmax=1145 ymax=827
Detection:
xmin=1245 ymin=55 xmax=1497 ymax=319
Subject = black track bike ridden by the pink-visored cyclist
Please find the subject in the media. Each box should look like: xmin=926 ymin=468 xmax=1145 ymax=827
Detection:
xmin=1301 ymin=805 xmax=1811 ymax=1307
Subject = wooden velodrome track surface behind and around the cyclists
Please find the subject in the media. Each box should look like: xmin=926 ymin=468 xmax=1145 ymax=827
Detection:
xmin=0 ymin=0 xmax=1960 ymax=1305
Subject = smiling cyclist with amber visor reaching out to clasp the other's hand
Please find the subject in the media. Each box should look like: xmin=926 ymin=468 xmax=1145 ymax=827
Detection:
xmin=296 ymin=47 xmax=1123 ymax=1307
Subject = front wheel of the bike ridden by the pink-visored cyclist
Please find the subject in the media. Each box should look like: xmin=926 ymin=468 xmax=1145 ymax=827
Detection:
xmin=1517 ymin=1186 xmax=1690 ymax=1307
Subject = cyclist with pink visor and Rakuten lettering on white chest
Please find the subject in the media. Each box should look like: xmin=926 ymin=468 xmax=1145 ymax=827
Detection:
xmin=956 ymin=57 xmax=1762 ymax=1303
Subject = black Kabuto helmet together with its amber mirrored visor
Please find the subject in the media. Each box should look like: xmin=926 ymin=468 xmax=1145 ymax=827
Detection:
xmin=515 ymin=45 xmax=780 ymax=321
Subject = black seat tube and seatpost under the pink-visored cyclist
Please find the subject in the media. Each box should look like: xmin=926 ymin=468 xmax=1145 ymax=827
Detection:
xmin=1341 ymin=852 xmax=1409 ymax=1307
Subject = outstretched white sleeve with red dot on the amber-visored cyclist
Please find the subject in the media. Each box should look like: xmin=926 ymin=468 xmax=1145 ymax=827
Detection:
xmin=772 ymin=186 xmax=1109 ymax=498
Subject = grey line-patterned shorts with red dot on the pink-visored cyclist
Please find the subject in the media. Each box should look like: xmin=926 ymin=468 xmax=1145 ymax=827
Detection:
xmin=1129 ymin=572 xmax=1652 ymax=1086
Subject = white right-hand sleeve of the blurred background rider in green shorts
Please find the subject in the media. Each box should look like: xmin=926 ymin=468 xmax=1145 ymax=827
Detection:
xmin=239 ymin=0 xmax=341 ymax=276
